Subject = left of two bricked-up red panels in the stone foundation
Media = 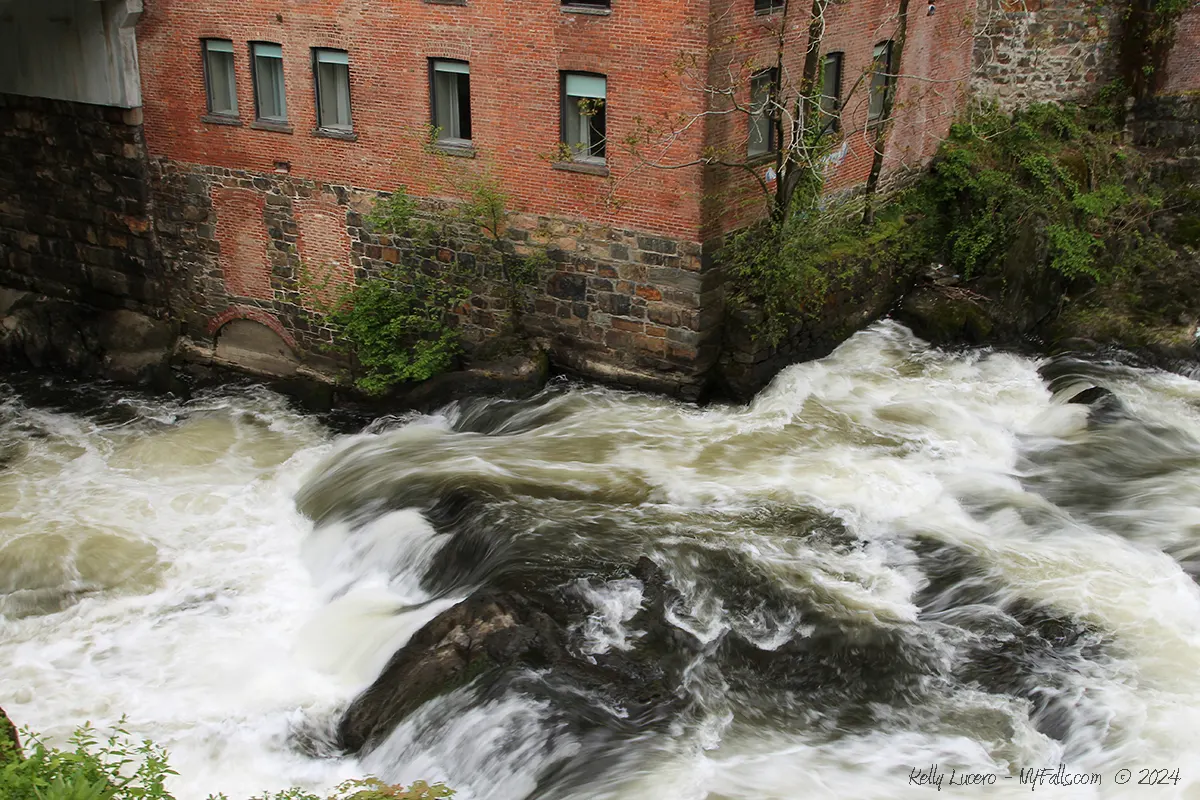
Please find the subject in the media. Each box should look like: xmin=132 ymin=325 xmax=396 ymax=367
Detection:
xmin=212 ymin=186 xmax=271 ymax=300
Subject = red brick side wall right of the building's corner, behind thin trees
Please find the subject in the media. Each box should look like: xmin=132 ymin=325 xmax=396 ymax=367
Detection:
xmin=702 ymin=0 xmax=974 ymax=241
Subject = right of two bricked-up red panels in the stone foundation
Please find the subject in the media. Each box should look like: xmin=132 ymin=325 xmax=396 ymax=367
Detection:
xmin=295 ymin=196 xmax=354 ymax=311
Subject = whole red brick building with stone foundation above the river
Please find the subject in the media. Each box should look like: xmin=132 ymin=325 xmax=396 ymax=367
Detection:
xmin=131 ymin=0 xmax=988 ymax=398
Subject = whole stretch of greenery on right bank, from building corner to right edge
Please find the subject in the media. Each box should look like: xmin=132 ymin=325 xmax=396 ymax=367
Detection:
xmin=721 ymin=97 xmax=1200 ymax=344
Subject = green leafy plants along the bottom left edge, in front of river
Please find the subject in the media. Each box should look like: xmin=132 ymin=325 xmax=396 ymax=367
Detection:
xmin=0 ymin=718 xmax=454 ymax=800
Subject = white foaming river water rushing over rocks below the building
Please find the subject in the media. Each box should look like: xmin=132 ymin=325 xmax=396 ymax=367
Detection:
xmin=0 ymin=323 xmax=1200 ymax=800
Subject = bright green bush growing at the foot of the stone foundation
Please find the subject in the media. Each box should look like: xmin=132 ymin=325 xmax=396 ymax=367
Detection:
xmin=326 ymin=265 xmax=470 ymax=395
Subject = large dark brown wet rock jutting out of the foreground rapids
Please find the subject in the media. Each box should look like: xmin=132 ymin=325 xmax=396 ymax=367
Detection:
xmin=338 ymin=558 xmax=697 ymax=752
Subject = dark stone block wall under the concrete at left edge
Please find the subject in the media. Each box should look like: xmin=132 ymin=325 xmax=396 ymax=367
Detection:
xmin=0 ymin=95 xmax=166 ymax=314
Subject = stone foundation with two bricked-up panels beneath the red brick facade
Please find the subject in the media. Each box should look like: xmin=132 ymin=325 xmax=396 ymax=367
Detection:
xmin=152 ymin=160 xmax=722 ymax=397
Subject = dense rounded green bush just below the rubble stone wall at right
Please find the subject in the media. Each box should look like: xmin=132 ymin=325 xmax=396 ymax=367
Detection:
xmin=906 ymin=103 xmax=1163 ymax=283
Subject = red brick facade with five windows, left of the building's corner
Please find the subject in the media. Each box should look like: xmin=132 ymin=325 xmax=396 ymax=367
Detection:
xmin=138 ymin=0 xmax=710 ymax=239
